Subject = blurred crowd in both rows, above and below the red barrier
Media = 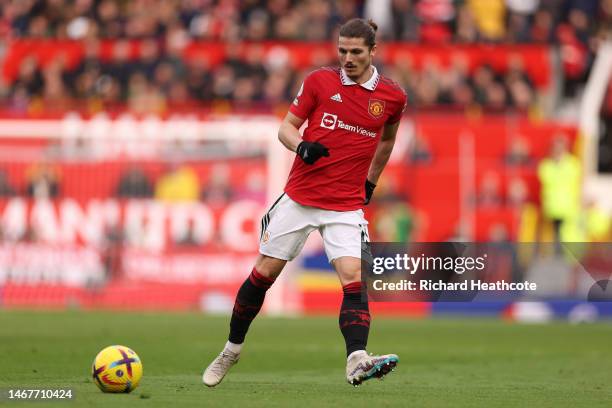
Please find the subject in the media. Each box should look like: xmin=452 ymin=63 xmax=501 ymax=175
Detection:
xmin=0 ymin=0 xmax=612 ymax=111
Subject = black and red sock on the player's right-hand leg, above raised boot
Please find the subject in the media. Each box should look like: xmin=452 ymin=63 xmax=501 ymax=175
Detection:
xmin=339 ymin=282 xmax=370 ymax=356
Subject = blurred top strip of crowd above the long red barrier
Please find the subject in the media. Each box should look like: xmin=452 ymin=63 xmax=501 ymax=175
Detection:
xmin=0 ymin=0 xmax=612 ymax=44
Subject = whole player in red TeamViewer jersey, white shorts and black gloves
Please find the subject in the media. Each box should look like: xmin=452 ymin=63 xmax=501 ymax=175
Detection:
xmin=203 ymin=19 xmax=406 ymax=387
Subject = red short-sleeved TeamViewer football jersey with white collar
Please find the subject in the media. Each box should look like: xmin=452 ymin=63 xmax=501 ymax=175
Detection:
xmin=285 ymin=67 xmax=406 ymax=211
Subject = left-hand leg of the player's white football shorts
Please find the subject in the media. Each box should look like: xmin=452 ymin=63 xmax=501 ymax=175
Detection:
xmin=259 ymin=195 xmax=316 ymax=261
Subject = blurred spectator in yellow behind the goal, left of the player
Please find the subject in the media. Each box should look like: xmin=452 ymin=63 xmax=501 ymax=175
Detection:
xmin=155 ymin=163 xmax=200 ymax=202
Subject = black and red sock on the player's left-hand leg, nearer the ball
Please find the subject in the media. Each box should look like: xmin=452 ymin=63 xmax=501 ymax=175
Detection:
xmin=228 ymin=268 xmax=274 ymax=344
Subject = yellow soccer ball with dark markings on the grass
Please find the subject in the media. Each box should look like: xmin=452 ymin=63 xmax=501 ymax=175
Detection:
xmin=91 ymin=346 xmax=142 ymax=392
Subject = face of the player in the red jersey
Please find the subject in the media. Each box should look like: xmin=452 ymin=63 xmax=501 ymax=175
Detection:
xmin=338 ymin=37 xmax=376 ymax=83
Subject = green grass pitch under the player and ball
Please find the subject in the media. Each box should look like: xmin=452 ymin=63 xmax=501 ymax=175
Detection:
xmin=0 ymin=311 xmax=612 ymax=408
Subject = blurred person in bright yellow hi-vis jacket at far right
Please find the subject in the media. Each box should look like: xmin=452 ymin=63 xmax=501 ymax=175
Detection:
xmin=538 ymin=135 xmax=581 ymax=249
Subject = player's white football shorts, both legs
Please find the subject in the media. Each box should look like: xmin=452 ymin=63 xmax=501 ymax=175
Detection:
xmin=259 ymin=194 xmax=370 ymax=263
